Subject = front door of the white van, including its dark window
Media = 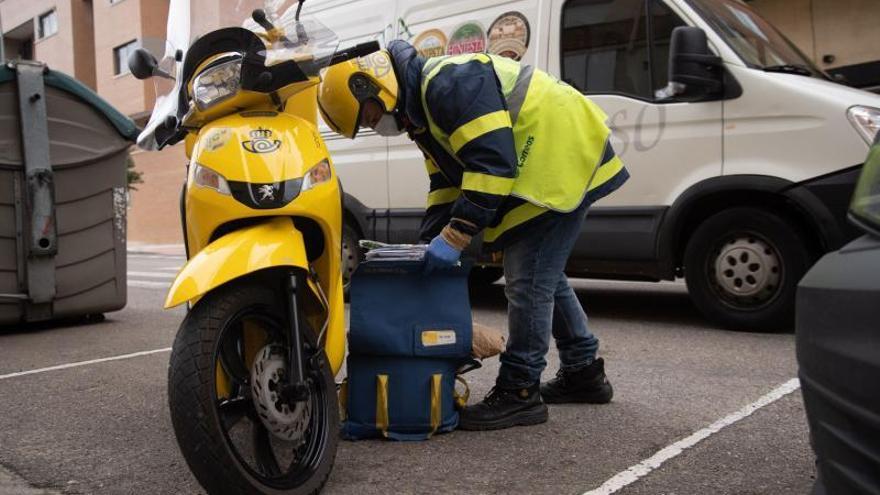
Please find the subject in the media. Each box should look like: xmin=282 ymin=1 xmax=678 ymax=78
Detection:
xmin=549 ymin=0 xmax=722 ymax=278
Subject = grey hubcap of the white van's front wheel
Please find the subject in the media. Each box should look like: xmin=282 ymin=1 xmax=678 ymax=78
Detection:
xmin=713 ymin=236 xmax=782 ymax=306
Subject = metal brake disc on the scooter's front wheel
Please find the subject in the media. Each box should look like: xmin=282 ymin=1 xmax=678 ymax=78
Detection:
xmin=251 ymin=344 xmax=312 ymax=446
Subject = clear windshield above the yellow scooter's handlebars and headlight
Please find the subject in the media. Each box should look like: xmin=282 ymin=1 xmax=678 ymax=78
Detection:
xmin=138 ymin=0 xmax=339 ymax=150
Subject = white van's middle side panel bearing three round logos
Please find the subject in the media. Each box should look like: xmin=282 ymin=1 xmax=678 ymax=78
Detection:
xmin=388 ymin=0 xmax=546 ymax=242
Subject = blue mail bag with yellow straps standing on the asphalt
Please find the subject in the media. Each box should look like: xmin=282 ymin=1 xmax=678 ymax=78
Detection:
xmin=341 ymin=261 xmax=472 ymax=440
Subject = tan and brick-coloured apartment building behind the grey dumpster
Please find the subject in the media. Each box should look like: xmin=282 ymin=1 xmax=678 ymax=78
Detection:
xmin=0 ymin=0 xmax=184 ymax=243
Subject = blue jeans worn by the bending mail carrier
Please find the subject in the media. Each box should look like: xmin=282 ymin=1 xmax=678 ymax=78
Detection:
xmin=497 ymin=203 xmax=599 ymax=388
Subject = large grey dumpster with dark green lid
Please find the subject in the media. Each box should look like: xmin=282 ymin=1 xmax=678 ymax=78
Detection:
xmin=0 ymin=62 xmax=137 ymax=325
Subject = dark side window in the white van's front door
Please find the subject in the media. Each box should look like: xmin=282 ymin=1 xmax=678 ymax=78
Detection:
xmin=560 ymin=0 xmax=685 ymax=100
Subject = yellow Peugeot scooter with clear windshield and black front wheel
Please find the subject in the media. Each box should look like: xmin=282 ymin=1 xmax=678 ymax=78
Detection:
xmin=129 ymin=0 xmax=379 ymax=494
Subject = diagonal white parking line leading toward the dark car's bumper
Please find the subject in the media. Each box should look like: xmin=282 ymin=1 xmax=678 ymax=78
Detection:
xmin=584 ymin=378 xmax=800 ymax=495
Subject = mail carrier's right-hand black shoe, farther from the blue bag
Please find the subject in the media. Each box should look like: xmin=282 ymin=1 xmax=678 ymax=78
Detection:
xmin=541 ymin=358 xmax=614 ymax=404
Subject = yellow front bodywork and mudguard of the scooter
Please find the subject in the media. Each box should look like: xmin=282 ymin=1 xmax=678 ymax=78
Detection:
xmin=165 ymin=87 xmax=345 ymax=376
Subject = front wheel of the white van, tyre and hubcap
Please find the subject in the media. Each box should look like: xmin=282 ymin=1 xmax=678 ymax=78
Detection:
xmin=684 ymin=208 xmax=810 ymax=331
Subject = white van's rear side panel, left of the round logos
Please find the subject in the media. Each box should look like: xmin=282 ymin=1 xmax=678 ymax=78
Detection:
xmin=307 ymin=0 xmax=397 ymax=241
